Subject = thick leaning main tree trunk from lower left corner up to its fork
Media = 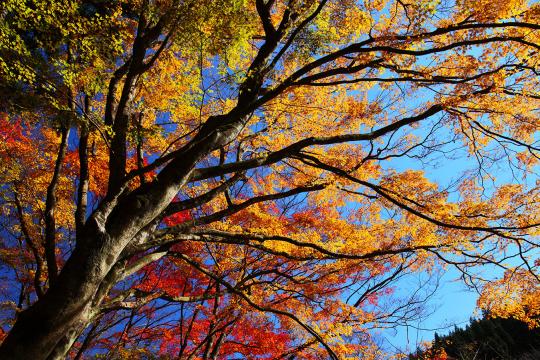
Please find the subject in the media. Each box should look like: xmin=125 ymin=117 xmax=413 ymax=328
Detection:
xmin=0 ymin=112 xmax=243 ymax=360
